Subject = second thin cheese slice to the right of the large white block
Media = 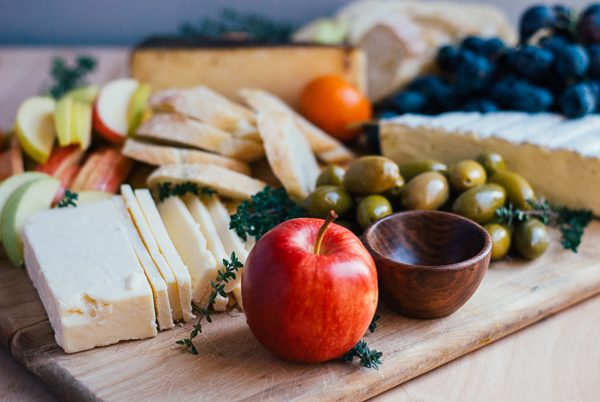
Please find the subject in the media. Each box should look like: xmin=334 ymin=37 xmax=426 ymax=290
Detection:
xmin=121 ymin=184 xmax=183 ymax=321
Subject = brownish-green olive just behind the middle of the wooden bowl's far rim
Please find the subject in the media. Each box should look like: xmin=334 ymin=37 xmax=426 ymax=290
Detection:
xmin=402 ymin=172 xmax=450 ymax=210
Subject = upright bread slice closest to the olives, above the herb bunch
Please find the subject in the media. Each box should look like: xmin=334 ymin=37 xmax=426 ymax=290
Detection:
xmin=258 ymin=112 xmax=320 ymax=202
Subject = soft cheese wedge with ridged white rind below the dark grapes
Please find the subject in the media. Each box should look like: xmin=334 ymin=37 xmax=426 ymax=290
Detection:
xmin=380 ymin=112 xmax=600 ymax=216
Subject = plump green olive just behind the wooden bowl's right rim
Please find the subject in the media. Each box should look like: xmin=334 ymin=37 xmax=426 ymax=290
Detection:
xmin=452 ymin=184 xmax=506 ymax=223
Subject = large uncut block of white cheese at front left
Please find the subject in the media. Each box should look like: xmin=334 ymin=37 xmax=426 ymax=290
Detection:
xmin=23 ymin=200 xmax=157 ymax=353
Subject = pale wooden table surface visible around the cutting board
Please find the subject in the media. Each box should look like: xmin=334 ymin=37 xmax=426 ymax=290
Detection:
xmin=0 ymin=48 xmax=600 ymax=401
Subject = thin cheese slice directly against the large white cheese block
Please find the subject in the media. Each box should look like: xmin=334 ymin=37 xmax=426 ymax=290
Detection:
xmin=112 ymin=195 xmax=173 ymax=330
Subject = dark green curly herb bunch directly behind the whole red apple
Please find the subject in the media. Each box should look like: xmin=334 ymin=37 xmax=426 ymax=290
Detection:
xmin=229 ymin=186 xmax=304 ymax=241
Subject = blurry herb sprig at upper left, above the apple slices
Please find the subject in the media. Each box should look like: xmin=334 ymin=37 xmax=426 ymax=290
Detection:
xmin=48 ymin=56 xmax=97 ymax=99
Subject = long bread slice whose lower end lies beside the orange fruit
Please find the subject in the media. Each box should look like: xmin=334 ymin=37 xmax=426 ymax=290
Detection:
xmin=240 ymin=88 xmax=354 ymax=163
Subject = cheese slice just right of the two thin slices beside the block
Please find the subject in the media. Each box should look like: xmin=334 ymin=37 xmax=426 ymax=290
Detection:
xmin=157 ymin=197 xmax=217 ymax=307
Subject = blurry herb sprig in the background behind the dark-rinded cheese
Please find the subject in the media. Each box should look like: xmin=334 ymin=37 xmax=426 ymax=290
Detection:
xmin=179 ymin=8 xmax=293 ymax=43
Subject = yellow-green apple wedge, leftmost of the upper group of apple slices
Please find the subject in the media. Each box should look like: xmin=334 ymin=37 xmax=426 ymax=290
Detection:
xmin=15 ymin=96 xmax=56 ymax=163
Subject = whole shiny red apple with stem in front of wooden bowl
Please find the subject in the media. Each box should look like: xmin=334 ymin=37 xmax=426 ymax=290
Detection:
xmin=242 ymin=217 xmax=378 ymax=363
